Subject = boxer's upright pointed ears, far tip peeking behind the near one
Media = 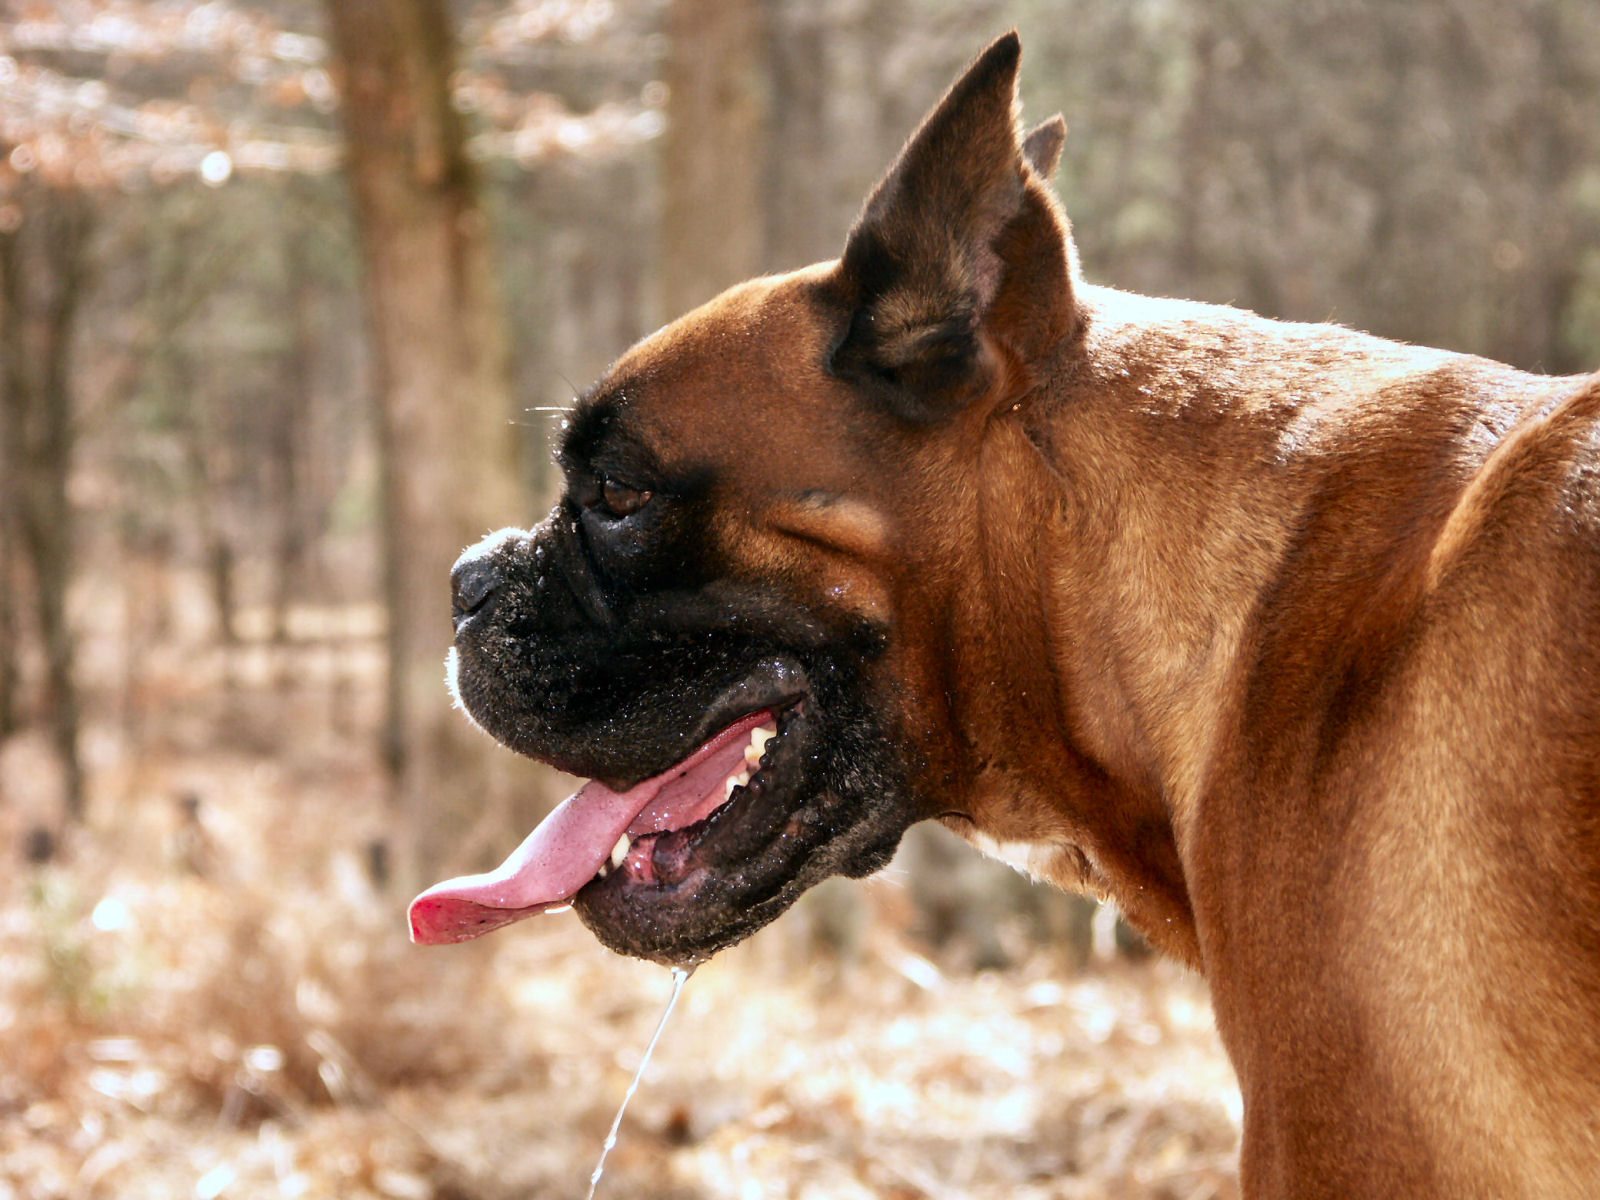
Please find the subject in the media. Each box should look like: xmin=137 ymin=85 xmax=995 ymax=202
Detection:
xmin=830 ymin=32 xmax=1077 ymax=424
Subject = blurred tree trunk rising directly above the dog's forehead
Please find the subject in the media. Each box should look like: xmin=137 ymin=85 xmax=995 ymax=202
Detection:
xmin=661 ymin=0 xmax=768 ymax=320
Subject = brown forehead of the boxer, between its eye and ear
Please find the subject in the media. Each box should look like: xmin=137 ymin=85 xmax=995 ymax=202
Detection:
xmin=558 ymin=264 xmax=845 ymax=483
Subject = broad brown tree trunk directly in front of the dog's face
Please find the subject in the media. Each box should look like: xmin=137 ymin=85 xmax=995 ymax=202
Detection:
xmin=325 ymin=0 xmax=525 ymax=883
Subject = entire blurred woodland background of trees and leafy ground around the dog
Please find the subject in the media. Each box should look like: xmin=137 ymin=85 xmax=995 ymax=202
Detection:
xmin=0 ymin=0 xmax=1600 ymax=1200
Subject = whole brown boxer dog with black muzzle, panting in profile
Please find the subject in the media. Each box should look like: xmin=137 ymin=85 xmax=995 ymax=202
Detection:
xmin=413 ymin=35 xmax=1600 ymax=1198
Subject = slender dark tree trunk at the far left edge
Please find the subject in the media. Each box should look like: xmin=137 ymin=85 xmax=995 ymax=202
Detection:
xmin=0 ymin=182 xmax=90 ymax=822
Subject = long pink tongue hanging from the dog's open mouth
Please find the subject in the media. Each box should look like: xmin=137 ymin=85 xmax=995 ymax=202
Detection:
xmin=410 ymin=712 xmax=771 ymax=946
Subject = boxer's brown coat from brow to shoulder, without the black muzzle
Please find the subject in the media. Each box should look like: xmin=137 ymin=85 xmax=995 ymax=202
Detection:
xmin=556 ymin=37 xmax=1600 ymax=1200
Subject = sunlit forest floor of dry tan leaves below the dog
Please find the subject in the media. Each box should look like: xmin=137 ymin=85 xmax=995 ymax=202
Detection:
xmin=0 ymin=640 xmax=1238 ymax=1200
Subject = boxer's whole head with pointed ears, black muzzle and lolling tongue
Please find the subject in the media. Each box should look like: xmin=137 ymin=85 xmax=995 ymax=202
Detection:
xmin=413 ymin=34 xmax=1077 ymax=962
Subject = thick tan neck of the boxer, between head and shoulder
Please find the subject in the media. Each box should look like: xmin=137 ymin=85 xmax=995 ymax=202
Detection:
xmin=952 ymin=286 xmax=1542 ymax=965
